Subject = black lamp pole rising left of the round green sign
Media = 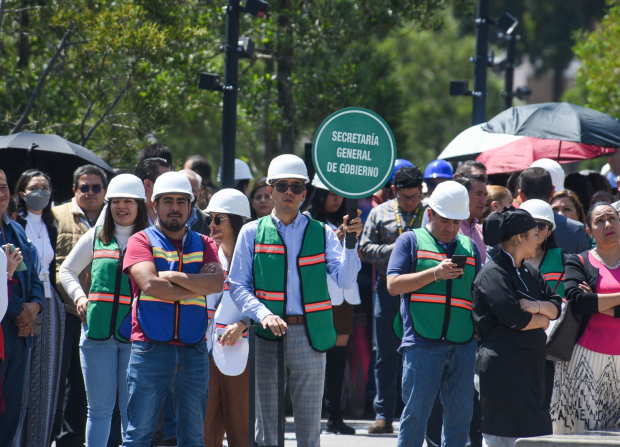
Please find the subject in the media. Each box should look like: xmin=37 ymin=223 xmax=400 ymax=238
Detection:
xmin=221 ymin=0 xmax=241 ymax=188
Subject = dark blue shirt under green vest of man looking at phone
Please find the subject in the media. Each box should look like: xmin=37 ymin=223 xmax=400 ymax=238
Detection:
xmin=387 ymin=230 xmax=481 ymax=352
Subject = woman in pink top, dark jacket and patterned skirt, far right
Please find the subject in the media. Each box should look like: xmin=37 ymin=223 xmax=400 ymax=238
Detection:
xmin=551 ymin=202 xmax=620 ymax=433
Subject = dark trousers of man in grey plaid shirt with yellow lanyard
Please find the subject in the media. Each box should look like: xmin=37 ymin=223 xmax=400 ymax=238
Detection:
xmin=375 ymin=279 xmax=402 ymax=424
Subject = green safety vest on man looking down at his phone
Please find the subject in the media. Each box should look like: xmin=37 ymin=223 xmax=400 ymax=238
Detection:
xmin=394 ymin=228 xmax=476 ymax=343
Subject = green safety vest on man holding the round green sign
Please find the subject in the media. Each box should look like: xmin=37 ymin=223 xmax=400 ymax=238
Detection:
xmin=253 ymin=216 xmax=336 ymax=352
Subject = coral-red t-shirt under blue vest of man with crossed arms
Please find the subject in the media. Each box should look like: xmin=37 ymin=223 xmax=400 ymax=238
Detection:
xmin=123 ymin=231 xmax=220 ymax=345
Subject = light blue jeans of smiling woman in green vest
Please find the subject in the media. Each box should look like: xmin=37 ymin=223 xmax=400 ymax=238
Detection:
xmin=80 ymin=325 xmax=131 ymax=447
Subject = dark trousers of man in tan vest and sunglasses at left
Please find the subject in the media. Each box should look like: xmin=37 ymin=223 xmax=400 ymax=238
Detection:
xmin=52 ymin=313 xmax=86 ymax=447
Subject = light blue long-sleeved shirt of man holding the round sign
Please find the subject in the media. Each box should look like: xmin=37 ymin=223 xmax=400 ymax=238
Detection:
xmin=228 ymin=211 xmax=361 ymax=321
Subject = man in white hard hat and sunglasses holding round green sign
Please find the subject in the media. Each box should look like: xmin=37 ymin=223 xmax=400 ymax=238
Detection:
xmin=229 ymin=154 xmax=362 ymax=447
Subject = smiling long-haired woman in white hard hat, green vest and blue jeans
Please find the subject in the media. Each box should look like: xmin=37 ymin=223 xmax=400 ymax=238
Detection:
xmin=60 ymin=174 xmax=148 ymax=447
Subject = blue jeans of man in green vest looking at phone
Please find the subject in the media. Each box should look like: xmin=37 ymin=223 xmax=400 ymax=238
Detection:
xmin=398 ymin=340 xmax=477 ymax=447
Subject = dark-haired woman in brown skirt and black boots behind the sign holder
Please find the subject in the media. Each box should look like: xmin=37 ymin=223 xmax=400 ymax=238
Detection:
xmin=309 ymin=175 xmax=361 ymax=435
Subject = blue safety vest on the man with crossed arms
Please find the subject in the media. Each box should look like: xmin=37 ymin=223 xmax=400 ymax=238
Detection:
xmin=136 ymin=226 xmax=209 ymax=344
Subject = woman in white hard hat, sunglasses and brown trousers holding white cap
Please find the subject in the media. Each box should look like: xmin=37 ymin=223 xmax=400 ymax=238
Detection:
xmin=204 ymin=189 xmax=250 ymax=447
